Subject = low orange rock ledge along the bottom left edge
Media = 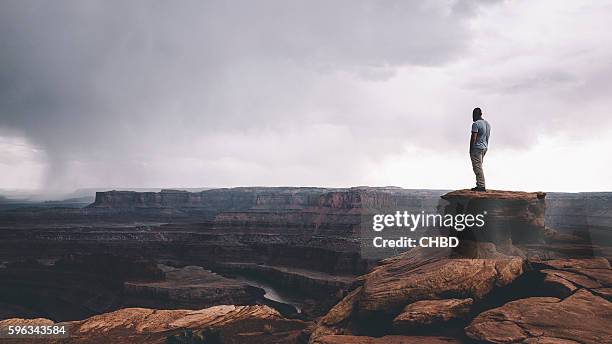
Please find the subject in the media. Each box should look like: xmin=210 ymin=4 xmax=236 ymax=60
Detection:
xmin=0 ymin=306 xmax=307 ymax=344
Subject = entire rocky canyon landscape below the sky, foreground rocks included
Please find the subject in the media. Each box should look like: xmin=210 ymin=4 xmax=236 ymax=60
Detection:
xmin=0 ymin=187 xmax=612 ymax=343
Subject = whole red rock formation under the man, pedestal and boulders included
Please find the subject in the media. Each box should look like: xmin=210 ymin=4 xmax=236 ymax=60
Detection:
xmin=310 ymin=191 xmax=612 ymax=343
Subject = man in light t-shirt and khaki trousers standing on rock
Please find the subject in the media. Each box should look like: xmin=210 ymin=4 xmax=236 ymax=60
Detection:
xmin=470 ymin=108 xmax=491 ymax=191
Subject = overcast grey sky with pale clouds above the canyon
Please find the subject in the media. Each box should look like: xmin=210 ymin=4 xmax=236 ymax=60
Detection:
xmin=0 ymin=0 xmax=612 ymax=191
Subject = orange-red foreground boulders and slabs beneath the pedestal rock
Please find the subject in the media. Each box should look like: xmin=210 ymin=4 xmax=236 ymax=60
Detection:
xmin=311 ymin=251 xmax=612 ymax=343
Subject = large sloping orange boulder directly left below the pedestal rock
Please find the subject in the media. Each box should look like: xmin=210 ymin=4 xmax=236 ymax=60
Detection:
xmin=312 ymin=243 xmax=524 ymax=340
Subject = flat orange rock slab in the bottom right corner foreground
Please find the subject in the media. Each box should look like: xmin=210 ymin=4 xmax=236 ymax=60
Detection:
xmin=465 ymin=289 xmax=612 ymax=343
